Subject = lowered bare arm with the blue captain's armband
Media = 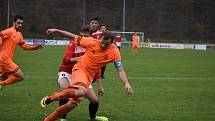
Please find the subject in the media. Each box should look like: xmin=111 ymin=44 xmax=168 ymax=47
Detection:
xmin=114 ymin=60 xmax=133 ymax=95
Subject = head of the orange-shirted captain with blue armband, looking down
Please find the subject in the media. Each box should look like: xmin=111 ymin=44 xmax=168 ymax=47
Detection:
xmin=100 ymin=31 xmax=114 ymax=50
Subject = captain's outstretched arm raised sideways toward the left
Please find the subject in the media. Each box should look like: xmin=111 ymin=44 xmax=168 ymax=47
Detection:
xmin=46 ymin=29 xmax=77 ymax=39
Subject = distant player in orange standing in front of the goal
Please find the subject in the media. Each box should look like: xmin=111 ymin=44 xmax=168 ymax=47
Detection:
xmin=132 ymin=32 xmax=139 ymax=55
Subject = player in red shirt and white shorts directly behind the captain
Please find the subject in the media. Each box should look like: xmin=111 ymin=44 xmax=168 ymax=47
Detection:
xmin=48 ymin=25 xmax=105 ymax=121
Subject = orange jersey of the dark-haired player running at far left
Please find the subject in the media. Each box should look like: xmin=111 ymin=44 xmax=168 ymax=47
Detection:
xmin=0 ymin=27 xmax=25 ymax=61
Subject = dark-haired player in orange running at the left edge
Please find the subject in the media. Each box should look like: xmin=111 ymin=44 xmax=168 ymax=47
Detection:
xmin=0 ymin=15 xmax=42 ymax=89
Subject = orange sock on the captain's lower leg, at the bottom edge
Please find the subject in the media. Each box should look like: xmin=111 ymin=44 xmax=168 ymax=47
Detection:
xmin=44 ymin=104 xmax=74 ymax=121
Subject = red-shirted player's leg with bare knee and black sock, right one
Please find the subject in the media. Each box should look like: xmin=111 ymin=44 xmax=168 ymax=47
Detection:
xmin=86 ymin=85 xmax=99 ymax=119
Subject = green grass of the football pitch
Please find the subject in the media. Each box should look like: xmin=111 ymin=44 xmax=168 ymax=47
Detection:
xmin=0 ymin=46 xmax=215 ymax=121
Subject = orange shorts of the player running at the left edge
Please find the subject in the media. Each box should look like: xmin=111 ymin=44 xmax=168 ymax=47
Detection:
xmin=0 ymin=60 xmax=19 ymax=76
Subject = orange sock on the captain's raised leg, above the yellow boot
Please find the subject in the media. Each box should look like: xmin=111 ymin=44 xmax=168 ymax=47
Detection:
xmin=49 ymin=88 xmax=77 ymax=101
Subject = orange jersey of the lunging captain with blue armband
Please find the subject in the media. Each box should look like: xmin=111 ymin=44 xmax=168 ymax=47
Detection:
xmin=75 ymin=37 xmax=121 ymax=81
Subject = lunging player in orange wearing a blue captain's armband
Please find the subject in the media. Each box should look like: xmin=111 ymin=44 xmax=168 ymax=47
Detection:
xmin=41 ymin=29 xmax=133 ymax=121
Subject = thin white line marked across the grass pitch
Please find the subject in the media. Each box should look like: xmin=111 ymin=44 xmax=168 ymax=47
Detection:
xmin=26 ymin=76 xmax=215 ymax=80
